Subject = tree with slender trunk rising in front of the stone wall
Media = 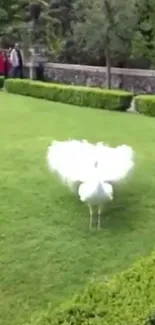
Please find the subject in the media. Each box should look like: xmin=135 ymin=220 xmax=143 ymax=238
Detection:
xmin=73 ymin=0 xmax=136 ymax=88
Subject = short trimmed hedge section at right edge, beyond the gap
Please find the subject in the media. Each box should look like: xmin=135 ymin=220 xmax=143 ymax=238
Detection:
xmin=135 ymin=95 xmax=155 ymax=116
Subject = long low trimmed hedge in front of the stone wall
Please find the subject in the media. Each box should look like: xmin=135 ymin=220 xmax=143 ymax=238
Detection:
xmin=5 ymin=79 xmax=132 ymax=111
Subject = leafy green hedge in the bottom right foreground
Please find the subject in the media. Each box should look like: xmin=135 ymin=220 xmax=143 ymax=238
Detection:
xmin=24 ymin=254 xmax=155 ymax=325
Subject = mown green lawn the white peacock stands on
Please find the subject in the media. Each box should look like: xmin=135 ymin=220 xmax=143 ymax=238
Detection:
xmin=0 ymin=92 xmax=155 ymax=325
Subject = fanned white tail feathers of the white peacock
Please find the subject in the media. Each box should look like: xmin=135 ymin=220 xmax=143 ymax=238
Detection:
xmin=47 ymin=140 xmax=134 ymax=192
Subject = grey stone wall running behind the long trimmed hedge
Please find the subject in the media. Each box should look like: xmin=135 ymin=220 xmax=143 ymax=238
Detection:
xmin=25 ymin=63 xmax=155 ymax=93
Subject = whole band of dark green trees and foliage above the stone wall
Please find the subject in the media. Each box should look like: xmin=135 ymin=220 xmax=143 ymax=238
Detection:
xmin=0 ymin=0 xmax=155 ymax=68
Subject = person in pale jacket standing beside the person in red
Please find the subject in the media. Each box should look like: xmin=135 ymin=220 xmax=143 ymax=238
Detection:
xmin=10 ymin=43 xmax=23 ymax=78
